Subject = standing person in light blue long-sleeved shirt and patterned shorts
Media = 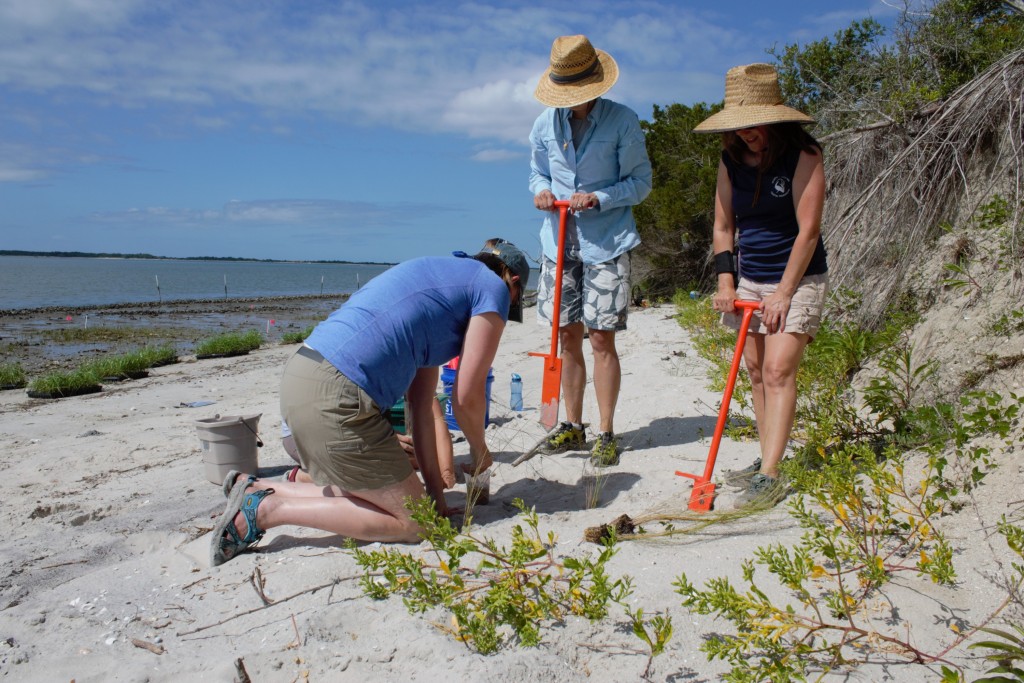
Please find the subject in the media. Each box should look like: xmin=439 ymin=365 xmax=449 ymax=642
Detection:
xmin=529 ymin=36 xmax=651 ymax=466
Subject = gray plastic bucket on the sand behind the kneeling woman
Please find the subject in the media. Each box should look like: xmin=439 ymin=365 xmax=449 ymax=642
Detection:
xmin=196 ymin=413 xmax=263 ymax=484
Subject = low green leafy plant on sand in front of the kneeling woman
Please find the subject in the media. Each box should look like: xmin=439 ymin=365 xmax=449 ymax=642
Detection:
xmin=351 ymin=498 xmax=638 ymax=656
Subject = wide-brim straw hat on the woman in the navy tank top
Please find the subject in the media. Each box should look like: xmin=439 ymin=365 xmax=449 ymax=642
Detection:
xmin=693 ymin=63 xmax=814 ymax=133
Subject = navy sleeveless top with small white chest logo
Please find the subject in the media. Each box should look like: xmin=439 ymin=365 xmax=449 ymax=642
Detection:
xmin=722 ymin=150 xmax=828 ymax=283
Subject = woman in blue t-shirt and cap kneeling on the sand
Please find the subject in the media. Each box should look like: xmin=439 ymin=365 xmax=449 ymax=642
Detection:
xmin=210 ymin=242 xmax=529 ymax=566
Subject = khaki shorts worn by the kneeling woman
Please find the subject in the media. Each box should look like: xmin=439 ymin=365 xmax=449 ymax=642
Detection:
xmin=281 ymin=346 xmax=413 ymax=492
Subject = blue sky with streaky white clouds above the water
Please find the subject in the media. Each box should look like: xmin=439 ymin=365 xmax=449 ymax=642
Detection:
xmin=0 ymin=0 xmax=895 ymax=262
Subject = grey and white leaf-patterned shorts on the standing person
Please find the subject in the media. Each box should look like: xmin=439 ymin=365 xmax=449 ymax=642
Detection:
xmin=537 ymin=252 xmax=630 ymax=331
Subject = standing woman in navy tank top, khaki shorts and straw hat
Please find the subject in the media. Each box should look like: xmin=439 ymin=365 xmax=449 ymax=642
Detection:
xmin=695 ymin=63 xmax=828 ymax=507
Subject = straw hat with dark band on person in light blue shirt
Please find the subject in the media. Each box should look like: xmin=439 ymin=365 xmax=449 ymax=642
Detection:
xmin=534 ymin=36 xmax=618 ymax=108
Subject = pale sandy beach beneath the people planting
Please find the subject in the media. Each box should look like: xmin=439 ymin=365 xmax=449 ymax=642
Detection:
xmin=0 ymin=306 xmax=1019 ymax=683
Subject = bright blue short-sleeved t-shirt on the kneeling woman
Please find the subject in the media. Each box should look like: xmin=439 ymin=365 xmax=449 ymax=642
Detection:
xmin=306 ymin=257 xmax=510 ymax=411
